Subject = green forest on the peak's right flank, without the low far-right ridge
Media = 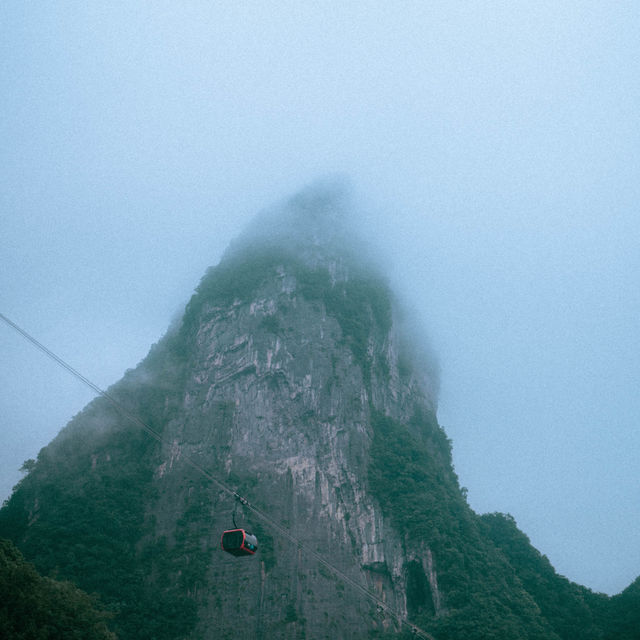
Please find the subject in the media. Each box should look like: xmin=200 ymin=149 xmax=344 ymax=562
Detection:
xmin=369 ymin=412 xmax=556 ymax=640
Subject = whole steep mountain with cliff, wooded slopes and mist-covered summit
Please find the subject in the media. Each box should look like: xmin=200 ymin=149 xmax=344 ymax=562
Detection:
xmin=0 ymin=187 xmax=639 ymax=640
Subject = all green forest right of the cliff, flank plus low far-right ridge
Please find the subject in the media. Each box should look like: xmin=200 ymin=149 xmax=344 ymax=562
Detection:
xmin=369 ymin=412 xmax=640 ymax=640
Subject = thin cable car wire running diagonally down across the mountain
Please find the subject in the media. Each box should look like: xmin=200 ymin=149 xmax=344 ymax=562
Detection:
xmin=0 ymin=313 xmax=435 ymax=640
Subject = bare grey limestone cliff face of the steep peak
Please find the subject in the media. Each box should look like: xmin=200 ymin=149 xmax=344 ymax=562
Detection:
xmin=150 ymin=188 xmax=440 ymax=638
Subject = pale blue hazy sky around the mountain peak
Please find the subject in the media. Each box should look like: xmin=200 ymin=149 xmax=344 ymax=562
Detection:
xmin=0 ymin=0 xmax=640 ymax=593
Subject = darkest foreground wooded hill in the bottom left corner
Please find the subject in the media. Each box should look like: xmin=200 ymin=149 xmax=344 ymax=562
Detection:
xmin=0 ymin=539 xmax=116 ymax=640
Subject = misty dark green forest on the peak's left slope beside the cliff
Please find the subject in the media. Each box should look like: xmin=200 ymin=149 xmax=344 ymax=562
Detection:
xmin=0 ymin=390 xmax=200 ymax=640
